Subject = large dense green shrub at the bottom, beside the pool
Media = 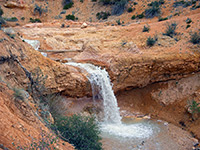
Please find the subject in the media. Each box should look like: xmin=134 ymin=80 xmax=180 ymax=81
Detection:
xmin=55 ymin=115 xmax=102 ymax=150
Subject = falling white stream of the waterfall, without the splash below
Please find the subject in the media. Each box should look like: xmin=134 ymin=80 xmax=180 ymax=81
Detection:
xmin=66 ymin=62 xmax=121 ymax=124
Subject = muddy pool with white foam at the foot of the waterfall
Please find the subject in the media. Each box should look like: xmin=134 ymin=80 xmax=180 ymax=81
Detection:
xmin=100 ymin=118 xmax=179 ymax=150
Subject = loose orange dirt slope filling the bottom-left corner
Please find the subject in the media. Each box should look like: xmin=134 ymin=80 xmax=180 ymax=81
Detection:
xmin=0 ymin=81 xmax=74 ymax=150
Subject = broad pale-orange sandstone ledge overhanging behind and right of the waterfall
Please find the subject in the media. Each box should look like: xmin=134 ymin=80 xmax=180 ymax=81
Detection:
xmin=16 ymin=15 xmax=200 ymax=95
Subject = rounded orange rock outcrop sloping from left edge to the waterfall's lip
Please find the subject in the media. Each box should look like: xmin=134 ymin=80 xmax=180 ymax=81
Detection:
xmin=0 ymin=31 xmax=90 ymax=97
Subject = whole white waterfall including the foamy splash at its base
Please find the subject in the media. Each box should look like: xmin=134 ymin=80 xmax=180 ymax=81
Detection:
xmin=66 ymin=62 xmax=159 ymax=144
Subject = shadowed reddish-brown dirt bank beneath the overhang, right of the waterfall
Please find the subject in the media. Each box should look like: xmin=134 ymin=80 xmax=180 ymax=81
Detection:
xmin=116 ymin=73 xmax=200 ymax=139
